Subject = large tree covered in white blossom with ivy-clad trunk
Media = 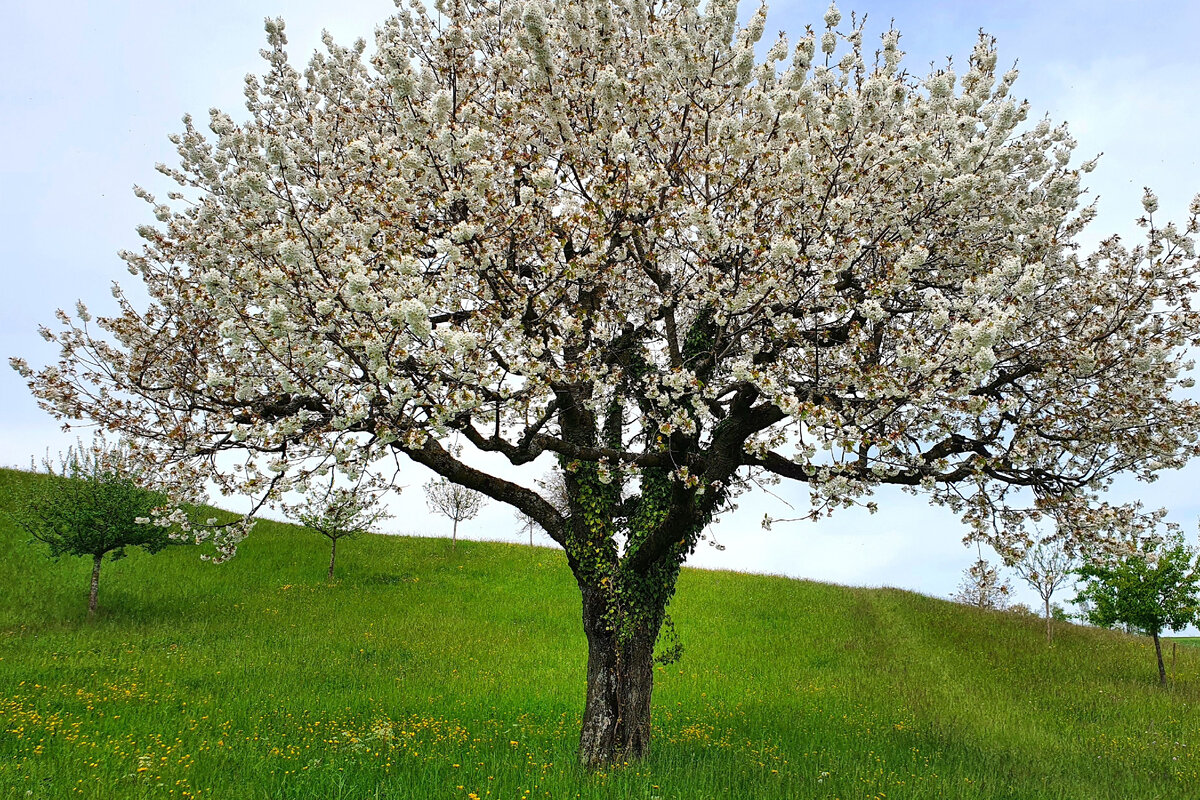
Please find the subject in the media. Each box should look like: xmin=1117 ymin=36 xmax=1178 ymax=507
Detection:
xmin=16 ymin=0 xmax=1200 ymax=765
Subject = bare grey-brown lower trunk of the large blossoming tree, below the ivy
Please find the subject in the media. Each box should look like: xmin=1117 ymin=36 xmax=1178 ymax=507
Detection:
xmin=580 ymin=593 xmax=659 ymax=769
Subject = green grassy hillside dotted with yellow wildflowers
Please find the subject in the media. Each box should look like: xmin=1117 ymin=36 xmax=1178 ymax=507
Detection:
xmin=0 ymin=471 xmax=1200 ymax=800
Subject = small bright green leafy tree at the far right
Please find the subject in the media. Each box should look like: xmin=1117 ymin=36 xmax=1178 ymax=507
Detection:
xmin=1075 ymin=533 xmax=1200 ymax=686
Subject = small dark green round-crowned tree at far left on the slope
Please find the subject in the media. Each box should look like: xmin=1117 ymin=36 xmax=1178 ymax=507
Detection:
xmin=12 ymin=435 xmax=172 ymax=618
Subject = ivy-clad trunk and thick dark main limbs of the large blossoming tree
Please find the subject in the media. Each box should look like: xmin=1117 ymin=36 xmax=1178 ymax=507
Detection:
xmin=406 ymin=311 xmax=753 ymax=769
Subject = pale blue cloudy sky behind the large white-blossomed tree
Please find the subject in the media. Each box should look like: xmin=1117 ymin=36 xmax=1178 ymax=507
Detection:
xmin=0 ymin=0 xmax=1200 ymax=623
